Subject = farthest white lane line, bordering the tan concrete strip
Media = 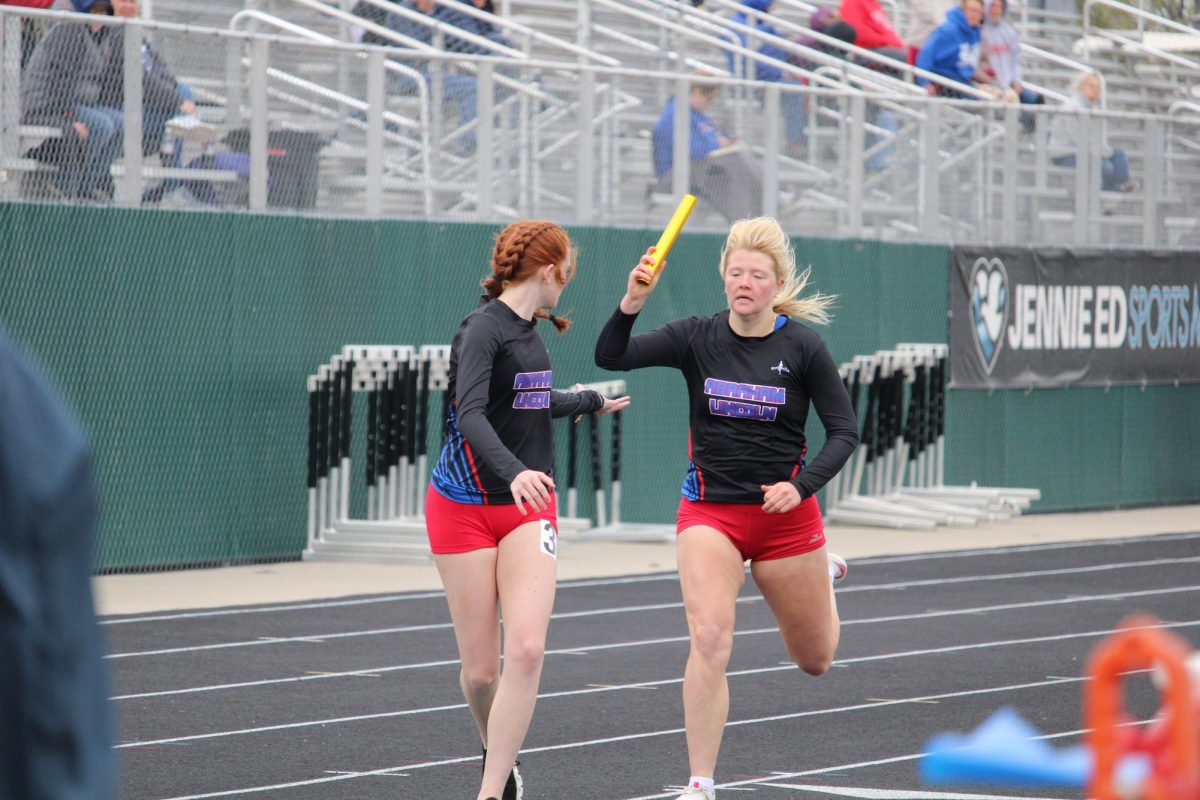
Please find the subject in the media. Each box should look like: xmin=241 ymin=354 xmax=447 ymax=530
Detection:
xmin=100 ymin=533 xmax=1200 ymax=625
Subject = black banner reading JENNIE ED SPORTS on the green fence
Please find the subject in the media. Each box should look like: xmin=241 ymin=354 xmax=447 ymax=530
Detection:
xmin=950 ymin=247 xmax=1200 ymax=389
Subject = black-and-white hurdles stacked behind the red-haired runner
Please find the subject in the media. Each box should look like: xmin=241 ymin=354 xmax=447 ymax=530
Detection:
xmin=304 ymin=352 xmax=674 ymax=563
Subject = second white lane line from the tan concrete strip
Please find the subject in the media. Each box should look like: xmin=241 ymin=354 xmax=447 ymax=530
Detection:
xmin=104 ymin=555 xmax=1200 ymax=660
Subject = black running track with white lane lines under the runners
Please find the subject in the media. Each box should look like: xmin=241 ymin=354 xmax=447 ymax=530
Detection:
xmin=103 ymin=533 xmax=1200 ymax=800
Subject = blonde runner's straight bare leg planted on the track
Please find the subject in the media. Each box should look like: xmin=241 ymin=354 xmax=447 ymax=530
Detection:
xmin=677 ymin=525 xmax=745 ymax=777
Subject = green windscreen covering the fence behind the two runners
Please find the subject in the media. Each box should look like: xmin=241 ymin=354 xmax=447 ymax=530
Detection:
xmin=0 ymin=204 xmax=1200 ymax=571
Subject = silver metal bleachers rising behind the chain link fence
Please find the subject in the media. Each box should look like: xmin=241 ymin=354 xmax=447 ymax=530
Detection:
xmin=0 ymin=0 xmax=1200 ymax=246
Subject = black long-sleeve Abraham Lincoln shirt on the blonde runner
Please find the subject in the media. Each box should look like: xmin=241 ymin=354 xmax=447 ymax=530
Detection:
xmin=595 ymin=308 xmax=858 ymax=503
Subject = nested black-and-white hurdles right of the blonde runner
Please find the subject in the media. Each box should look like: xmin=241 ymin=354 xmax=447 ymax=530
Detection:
xmin=826 ymin=343 xmax=1040 ymax=530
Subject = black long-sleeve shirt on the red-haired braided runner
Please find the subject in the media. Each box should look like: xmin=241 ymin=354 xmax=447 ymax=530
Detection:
xmin=432 ymin=300 xmax=604 ymax=504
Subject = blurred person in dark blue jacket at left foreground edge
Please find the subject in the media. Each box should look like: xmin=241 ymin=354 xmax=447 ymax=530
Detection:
xmin=0 ymin=330 xmax=116 ymax=800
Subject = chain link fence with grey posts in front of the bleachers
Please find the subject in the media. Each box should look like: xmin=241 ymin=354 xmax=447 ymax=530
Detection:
xmin=0 ymin=0 xmax=1200 ymax=247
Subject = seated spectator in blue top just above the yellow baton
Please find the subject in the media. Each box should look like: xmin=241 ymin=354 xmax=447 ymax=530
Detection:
xmin=652 ymin=80 xmax=762 ymax=222
